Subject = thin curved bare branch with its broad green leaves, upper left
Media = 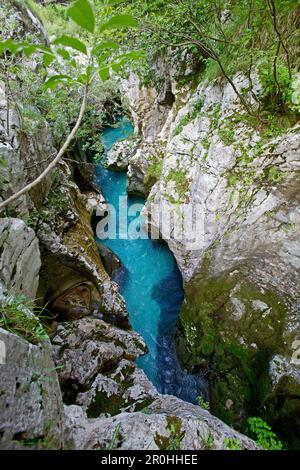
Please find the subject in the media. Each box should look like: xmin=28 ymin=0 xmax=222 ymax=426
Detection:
xmin=0 ymin=0 xmax=139 ymax=211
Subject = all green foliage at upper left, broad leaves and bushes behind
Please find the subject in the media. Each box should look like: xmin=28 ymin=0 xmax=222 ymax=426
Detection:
xmin=0 ymin=0 xmax=140 ymax=179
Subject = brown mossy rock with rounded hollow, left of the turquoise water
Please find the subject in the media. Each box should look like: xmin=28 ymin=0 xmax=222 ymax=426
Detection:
xmin=38 ymin=163 xmax=128 ymax=324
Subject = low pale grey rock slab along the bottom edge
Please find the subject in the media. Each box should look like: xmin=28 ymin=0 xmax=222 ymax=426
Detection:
xmin=65 ymin=395 xmax=258 ymax=450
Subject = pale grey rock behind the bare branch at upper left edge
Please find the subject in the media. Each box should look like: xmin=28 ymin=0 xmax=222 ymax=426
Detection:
xmin=0 ymin=1 xmax=56 ymax=215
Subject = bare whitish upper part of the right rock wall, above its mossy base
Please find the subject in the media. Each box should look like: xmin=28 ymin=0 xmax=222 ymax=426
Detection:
xmin=145 ymin=75 xmax=300 ymax=281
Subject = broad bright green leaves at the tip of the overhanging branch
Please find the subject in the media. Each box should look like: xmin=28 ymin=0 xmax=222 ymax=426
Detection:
xmin=0 ymin=0 xmax=139 ymax=103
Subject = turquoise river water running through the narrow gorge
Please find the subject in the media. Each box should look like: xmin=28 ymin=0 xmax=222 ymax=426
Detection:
xmin=96 ymin=118 xmax=208 ymax=403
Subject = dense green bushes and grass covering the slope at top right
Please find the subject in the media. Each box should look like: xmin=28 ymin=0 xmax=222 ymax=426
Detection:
xmin=108 ymin=0 xmax=300 ymax=123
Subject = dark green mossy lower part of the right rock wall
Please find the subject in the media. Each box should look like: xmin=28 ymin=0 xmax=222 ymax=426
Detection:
xmin=177 ymin=257 xmax=300 ymax=439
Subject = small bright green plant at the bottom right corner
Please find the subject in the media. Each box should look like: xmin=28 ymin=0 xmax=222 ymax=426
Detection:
xmin=247 ymin=416 xmax=283 ymax=450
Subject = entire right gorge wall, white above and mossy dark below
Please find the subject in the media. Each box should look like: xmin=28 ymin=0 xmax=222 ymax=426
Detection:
xmin=121 ymin=63 xmax=300 ymax=440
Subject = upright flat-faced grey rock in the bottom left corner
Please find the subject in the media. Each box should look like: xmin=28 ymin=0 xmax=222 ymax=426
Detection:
xmin=0 ymin=329 xmax=63 ymax=449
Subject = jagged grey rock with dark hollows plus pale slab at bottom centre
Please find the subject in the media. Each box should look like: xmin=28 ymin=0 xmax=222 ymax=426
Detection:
xmin=53 ymin=318 xmax=257 ymax=450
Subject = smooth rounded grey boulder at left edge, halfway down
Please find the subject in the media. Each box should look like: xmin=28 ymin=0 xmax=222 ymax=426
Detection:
xmin=0 ymin=218 xmax=41 ymax=299
